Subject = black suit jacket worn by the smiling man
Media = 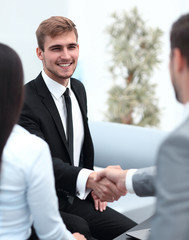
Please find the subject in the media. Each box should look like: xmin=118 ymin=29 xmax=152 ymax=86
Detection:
xmin=19 ymin=74 xmax=94 ymax=208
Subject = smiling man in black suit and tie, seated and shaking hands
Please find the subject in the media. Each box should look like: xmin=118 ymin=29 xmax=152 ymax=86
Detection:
xmin=19 ymin=17 xmax=136 ymax=240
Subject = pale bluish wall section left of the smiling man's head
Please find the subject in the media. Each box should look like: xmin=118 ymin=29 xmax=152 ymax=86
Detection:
xmin=0 ymin=0 xmax=68 ymax=82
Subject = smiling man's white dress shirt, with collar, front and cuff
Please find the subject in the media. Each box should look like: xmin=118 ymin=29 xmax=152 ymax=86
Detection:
xmin=42 ymin=70 xmax=92 ymax=199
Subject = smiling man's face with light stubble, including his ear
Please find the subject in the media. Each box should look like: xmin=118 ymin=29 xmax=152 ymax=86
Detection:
xmin=37 ymin=32 xmax=79 ymax=86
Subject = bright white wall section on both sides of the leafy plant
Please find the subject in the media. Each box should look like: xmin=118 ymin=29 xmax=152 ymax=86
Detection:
xmin=67 ymin=0 xmax=188 ymax=130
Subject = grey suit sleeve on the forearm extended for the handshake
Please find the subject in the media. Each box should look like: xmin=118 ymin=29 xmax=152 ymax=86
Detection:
xmin=132 ymin=167 xmax=156 ymax=197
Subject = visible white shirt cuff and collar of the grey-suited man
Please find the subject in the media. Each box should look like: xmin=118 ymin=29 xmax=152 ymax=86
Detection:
xmin=125 ymin=102 xmax=189 ymax=193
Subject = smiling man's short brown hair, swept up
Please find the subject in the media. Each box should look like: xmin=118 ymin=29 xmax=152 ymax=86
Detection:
xmin=36 ymin=16 xmax=78 ymax=51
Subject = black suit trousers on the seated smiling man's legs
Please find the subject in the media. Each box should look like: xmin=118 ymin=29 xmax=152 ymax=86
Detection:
xmin=60 ymin=195 xmax=136 ymax=240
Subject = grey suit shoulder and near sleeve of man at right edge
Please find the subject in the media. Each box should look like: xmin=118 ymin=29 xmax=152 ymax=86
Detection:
xmin=150 ymin=129 xmax=189 ymax=240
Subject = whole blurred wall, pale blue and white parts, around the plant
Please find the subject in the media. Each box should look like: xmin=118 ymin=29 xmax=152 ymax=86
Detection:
xmin=0 ymin=0 xmax=189 ymax=131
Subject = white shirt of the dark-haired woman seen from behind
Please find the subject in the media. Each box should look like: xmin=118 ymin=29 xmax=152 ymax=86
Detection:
xmin=0 ymin=125 xmax=75 ymax=240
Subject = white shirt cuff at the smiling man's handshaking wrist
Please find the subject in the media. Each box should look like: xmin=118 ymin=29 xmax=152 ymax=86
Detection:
xmin=76 ymin=168 xmax=93 ymax=200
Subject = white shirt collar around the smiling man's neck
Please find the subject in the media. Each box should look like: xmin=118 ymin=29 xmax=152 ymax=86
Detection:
xmin=41 ymin=70 xmax=71 ymax=99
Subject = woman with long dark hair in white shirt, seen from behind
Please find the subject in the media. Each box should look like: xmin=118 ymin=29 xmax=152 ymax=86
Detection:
xmin=0 ymin=44 xmax=85 ymax=240
